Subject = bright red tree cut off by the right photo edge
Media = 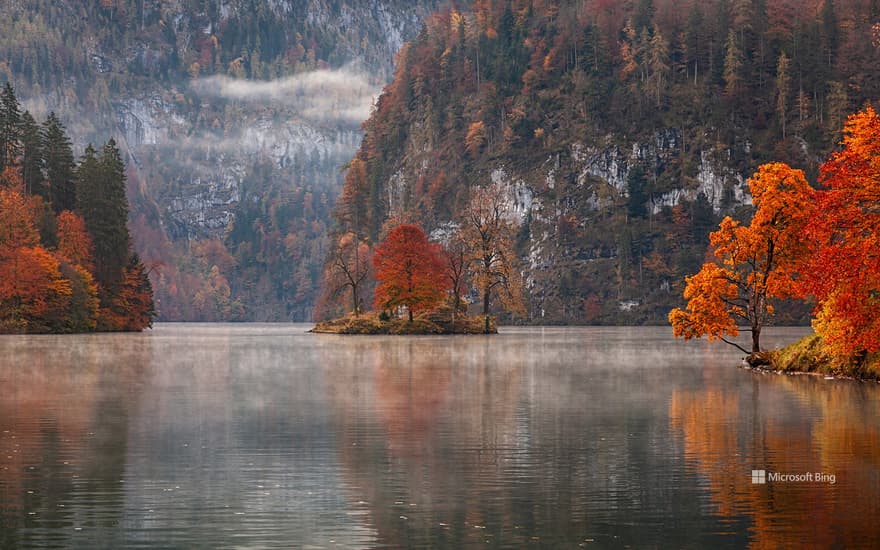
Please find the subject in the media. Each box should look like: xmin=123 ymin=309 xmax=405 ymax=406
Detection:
xmin=801 ymin=108 xmax=880 ymax=356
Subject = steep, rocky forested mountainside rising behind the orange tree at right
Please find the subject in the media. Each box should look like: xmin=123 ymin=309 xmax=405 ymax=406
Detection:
xmin=328 ymin=0 xmax=880 ymax=323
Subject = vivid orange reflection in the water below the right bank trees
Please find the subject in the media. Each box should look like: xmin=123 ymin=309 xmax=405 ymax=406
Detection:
xmin=670 ymin=372 xmax=880 ymax=548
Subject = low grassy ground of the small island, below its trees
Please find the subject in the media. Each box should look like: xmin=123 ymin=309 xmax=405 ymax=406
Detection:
xmin=311 ymin=312 xmax=498 ymax=334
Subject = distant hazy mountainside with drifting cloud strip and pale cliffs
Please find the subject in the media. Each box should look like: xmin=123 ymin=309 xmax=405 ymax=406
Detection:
xmin=0 ymin=0 xmax=443 ymax=321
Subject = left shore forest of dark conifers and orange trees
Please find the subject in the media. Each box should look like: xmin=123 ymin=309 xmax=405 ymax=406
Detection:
xmin=0 ymin=83 xmax=155 ymax=333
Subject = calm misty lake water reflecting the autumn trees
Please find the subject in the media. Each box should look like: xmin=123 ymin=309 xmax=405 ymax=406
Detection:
xmin=0 ymin=325 xmax=880 ymax=548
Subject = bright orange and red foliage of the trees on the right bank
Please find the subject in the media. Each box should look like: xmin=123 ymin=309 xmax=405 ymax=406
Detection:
xmin=669 ymin=107 xmax=880 ymax=360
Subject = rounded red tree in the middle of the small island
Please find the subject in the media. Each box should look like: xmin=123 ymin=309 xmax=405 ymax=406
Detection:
xmin=373 ymin=224 xmax=449 ymax=321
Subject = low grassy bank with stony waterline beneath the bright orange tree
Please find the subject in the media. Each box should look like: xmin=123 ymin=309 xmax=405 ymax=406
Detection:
xmin=742 ymin=334 xmax=880 ymax=382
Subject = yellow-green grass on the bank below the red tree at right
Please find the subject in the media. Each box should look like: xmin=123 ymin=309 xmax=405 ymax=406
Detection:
xmin=767 ymin=334 xmax=880 ymax=380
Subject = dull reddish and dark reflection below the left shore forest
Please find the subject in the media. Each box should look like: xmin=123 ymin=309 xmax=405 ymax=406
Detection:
xmin=0 ymin=337 xmax=151 ymax=548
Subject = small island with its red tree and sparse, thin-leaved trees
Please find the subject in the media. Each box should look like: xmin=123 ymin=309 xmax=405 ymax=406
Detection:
xmin=310 ymin=194 xmax=524 ymax=335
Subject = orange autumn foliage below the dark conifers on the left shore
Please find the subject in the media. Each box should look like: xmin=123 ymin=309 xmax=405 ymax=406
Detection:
xmin=0 ymin=162 xmax=155 ymax=333
